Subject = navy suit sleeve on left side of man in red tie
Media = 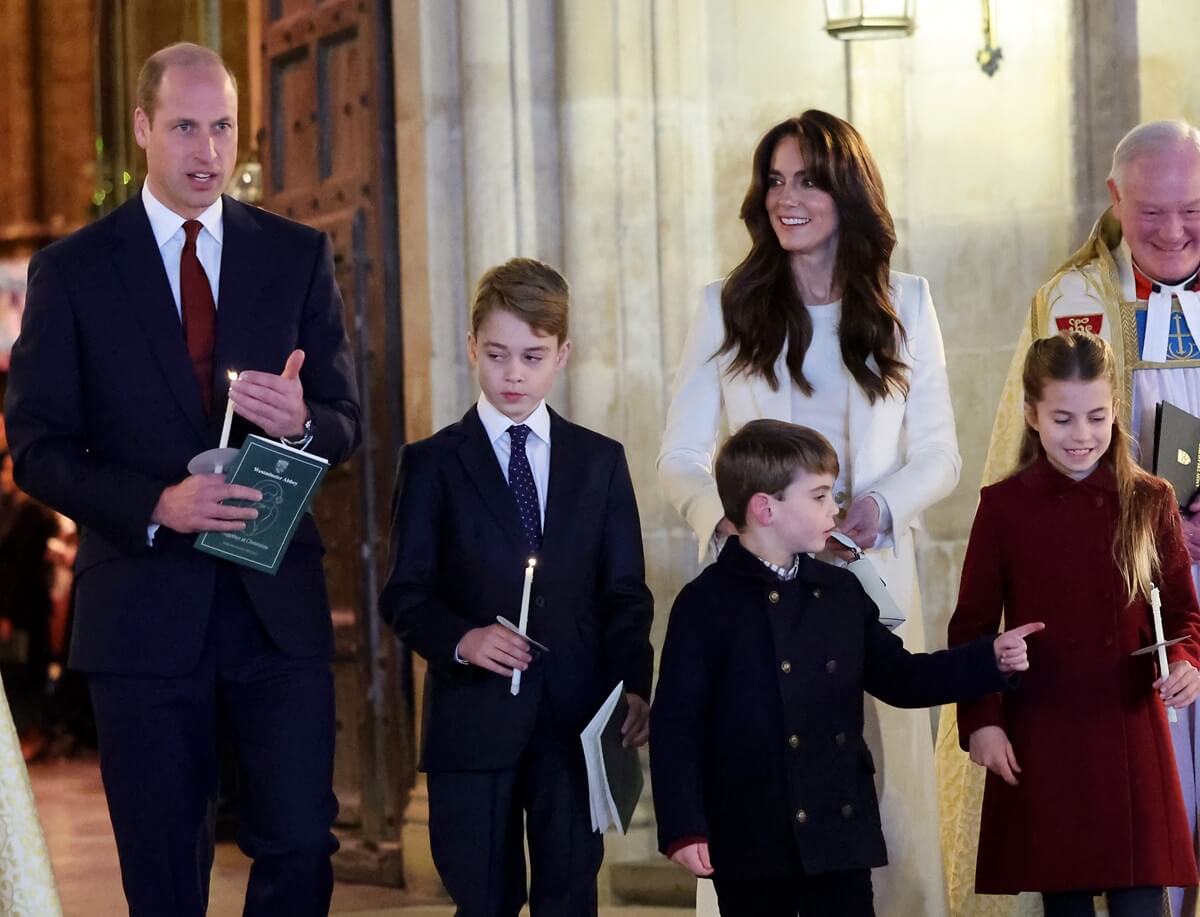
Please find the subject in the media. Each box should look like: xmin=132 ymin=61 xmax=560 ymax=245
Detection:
xmin=5 ymin=252 xmax=170 ymax=551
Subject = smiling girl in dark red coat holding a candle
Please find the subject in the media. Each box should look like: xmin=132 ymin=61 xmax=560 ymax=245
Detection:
xmin=949 ymin=332 xmax=1200 ymax=917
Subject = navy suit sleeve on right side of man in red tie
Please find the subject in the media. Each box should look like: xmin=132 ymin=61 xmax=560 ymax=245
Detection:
xmin=296 ymin=233 xmax=362 ymax=465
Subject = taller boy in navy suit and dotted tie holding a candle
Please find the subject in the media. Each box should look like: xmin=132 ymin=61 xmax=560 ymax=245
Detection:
xmin=380 ymin=258 xmax=653 ymax=917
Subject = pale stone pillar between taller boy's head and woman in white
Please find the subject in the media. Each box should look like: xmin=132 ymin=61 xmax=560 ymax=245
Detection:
xmin=560 ymin=0 xmax=665 ymax=863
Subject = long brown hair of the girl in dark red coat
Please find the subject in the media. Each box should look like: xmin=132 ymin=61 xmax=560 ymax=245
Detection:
xmin=1016 ymin=331 xmax=1162 ymax=601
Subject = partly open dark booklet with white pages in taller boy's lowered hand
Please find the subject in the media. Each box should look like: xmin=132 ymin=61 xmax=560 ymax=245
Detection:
xmin=580 ymin=682 xmax=644 ymax=834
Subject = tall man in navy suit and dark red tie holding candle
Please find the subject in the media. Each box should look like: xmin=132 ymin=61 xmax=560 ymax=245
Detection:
xmin=6 ymin=44 xmax=360 ymax=917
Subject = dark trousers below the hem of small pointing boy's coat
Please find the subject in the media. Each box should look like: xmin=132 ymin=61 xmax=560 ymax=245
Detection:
xmin=713 ymin=869 xmax=875 ymax=917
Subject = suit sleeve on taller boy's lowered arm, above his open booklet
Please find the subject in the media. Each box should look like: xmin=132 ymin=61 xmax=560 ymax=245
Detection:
xmin=601 ymin=446 xmax=654 ymax=701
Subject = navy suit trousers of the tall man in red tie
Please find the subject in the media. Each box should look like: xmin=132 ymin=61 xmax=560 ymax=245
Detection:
xmin=89 ymin=564 xmax=337 ymax=917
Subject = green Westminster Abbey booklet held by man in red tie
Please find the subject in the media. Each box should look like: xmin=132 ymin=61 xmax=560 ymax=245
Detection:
xmin=196 ymin=433 xmax=329 ymax=574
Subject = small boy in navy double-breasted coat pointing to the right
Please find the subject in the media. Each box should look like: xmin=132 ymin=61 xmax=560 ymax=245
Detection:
xmin=650 ymin=420 xmax=1042 ymax=917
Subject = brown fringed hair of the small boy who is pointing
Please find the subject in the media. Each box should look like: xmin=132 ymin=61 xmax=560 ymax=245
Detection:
xmin=713 ymin=420 xmax=838 ymax=531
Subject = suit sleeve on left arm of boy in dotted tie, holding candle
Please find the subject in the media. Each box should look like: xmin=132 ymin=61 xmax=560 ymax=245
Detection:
xmin=379 ymin=443 xmax=475 ymax=665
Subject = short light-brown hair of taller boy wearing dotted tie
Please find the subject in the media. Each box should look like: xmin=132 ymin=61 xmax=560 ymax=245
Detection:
xmin=470 ymin=258 xmax=570 ymax=343
